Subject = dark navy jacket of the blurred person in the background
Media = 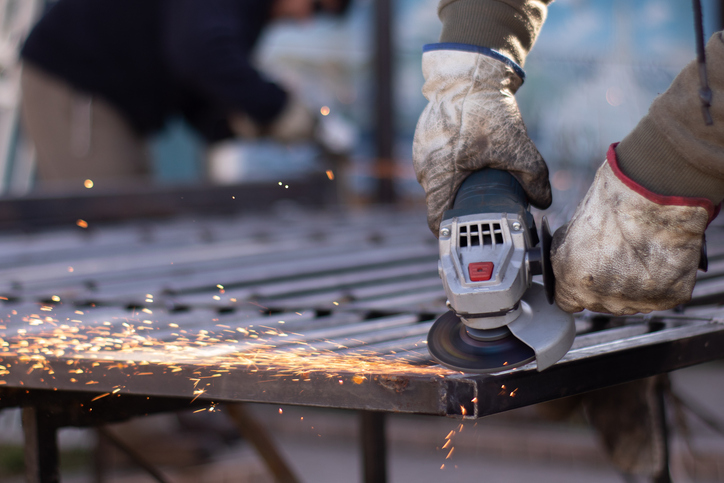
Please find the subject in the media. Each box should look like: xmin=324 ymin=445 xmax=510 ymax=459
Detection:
xmin=21 ymin=0 xmax=286 ymax=140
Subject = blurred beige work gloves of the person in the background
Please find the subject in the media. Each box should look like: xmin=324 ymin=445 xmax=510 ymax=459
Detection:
xmin=229 ymin=95 xmax=317 ymax=144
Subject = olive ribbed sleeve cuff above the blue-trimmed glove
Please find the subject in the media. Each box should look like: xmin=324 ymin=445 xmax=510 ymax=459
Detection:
xmin=438 ymin=0 xmax=553 ymax=66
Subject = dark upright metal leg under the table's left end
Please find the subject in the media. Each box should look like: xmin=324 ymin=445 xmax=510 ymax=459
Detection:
xmin=22 ymin=406 xmax=60 ymax=483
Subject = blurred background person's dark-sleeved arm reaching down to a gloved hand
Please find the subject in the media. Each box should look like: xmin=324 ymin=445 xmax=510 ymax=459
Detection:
xmin=161 ymin=0 xmax=314 ymax=140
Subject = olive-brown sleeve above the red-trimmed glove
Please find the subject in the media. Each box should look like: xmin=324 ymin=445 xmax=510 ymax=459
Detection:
xmin=616 ymin=32 xmax=724 ymax=204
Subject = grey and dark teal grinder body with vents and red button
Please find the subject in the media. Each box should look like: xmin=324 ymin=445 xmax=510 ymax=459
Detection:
xmin=438 ymin=169 xmax=543 ymax=329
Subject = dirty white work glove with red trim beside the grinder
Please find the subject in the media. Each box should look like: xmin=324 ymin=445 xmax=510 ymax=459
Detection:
xmin=551 ymin=145 xmax=717 ymax=315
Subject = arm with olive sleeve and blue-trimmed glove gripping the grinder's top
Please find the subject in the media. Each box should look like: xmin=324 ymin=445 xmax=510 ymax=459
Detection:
xmin=413 ymin=0 xmax=551 ymax=235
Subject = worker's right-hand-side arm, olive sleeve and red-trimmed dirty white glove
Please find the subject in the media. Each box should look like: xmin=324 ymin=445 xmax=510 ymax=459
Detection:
xmin=551 ymin=32 xmax=724 ymax=314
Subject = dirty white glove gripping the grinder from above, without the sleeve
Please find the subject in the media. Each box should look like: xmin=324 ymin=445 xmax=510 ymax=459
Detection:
xmin=413 ymin=50 xmax=551 ymax=236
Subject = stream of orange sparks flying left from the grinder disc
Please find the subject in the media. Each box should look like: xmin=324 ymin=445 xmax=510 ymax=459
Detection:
xmin=0 ymin=306 xmax=452 ymax=408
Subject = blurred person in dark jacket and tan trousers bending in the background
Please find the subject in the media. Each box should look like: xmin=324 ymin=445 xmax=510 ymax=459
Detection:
xmin=21 ymin=0 xmax=350 ymax=191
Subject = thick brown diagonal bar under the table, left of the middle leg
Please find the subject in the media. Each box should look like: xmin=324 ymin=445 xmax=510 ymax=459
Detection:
xmin=224 ymin=404 xmax=299 ymax=483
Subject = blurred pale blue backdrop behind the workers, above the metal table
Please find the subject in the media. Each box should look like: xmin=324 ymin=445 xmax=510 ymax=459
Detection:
xmin=0 ymin=0 xmax=722 ymax=211
